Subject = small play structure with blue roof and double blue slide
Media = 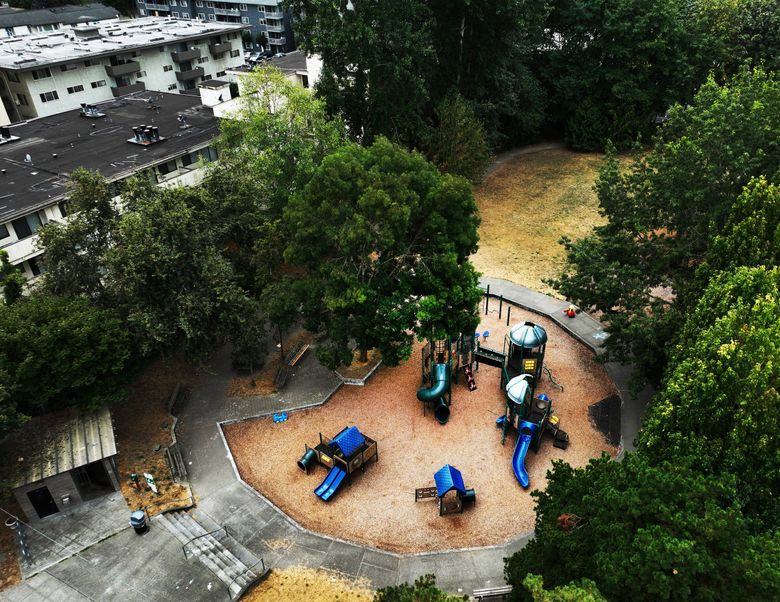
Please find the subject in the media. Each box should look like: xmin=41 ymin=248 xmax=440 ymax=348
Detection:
xmin=298 ymin=426 xmax=379 ymax=502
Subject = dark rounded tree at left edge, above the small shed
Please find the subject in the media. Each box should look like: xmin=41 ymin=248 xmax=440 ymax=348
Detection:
xmin=0 ymin=293 xmax=131 ymax=426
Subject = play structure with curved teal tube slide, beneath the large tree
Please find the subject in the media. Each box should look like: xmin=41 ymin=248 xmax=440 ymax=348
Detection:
xmin=417 ymin=334 xmax=477 ymax=424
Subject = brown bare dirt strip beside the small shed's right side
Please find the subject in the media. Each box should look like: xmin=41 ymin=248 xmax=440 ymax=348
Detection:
xmin=111 ymin=360 xmax=195 ymax=516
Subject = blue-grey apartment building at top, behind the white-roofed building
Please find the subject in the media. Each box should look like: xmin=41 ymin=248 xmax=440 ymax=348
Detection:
xmin=136 ymin=0 xmax=295 ymax=54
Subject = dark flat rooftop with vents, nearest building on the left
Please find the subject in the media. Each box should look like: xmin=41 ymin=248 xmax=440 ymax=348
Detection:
xmin=0 ymin=90 xmax=219 ymax=223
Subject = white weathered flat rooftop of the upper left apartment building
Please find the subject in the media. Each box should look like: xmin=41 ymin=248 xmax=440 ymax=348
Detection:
xmin=0 ymin=17 xmax=249 ymax=71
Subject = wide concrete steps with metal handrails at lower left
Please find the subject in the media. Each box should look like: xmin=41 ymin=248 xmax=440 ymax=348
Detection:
xmin=159 ymin=511 xmax=261 ymax=600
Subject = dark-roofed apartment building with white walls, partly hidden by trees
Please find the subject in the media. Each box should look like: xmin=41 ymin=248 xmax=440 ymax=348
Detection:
xmin=0 ymin=91 xmax=219 ymax=279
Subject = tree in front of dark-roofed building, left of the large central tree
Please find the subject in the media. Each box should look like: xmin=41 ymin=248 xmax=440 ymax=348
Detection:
xmin=106 ymin=186 xmax=243 ymax=356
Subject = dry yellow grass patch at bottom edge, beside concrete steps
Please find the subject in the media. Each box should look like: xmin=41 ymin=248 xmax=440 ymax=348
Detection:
xmin=241 ymin=567 xmax=374 ymax=602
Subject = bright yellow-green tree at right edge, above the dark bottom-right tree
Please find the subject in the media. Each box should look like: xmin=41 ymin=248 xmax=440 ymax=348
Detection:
xmin=639 ymin=267 xmax=780 ymax=528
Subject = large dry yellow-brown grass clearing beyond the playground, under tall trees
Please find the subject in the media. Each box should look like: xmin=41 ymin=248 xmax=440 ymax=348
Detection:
xmin=471 ymin=149 xmax=605 ymax=295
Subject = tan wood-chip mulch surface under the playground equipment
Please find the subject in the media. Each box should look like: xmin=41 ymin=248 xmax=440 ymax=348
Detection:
xmin=225 ymin=308 xmax=616 ymax=553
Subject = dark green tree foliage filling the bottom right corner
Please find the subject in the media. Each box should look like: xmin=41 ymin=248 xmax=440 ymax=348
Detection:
xmin=506 ymin=454 xmax=780 ymax=601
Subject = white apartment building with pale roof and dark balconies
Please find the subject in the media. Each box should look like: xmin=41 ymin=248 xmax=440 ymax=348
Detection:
xmin=0 ymin=17 xmax=247 ymax=125
